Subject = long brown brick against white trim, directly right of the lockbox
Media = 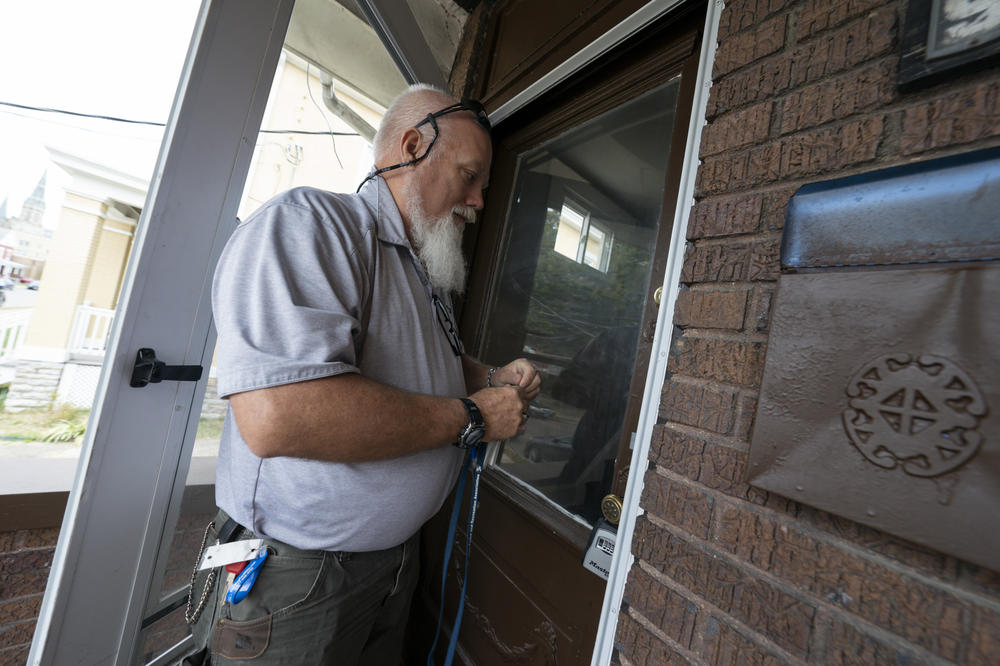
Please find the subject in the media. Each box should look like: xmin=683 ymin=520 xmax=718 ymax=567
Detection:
xmin=633 ymin=518 xmax=815 ymax=657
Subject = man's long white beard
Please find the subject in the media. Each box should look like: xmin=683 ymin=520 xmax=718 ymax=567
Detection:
xmin=408 ymin=188 xmax=475 ymax=295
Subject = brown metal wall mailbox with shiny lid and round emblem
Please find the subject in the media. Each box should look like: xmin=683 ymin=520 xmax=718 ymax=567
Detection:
xmin=747 ymin=144 xmax=1000 ymax=570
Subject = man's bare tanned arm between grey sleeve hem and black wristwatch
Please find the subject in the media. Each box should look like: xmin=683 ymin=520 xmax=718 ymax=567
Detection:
xmin=230 ymin=374 xmax=468 ymax=462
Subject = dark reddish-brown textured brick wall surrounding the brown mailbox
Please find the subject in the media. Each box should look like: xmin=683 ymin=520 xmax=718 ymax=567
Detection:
xmin=615 ymin=0 xmax=1000 ymax=664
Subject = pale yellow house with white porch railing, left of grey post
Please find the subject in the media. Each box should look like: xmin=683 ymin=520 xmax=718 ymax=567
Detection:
xmin=5 ymin=149 xmax=148 ymax=411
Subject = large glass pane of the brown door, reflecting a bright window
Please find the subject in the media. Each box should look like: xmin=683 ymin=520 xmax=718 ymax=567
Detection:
xmin=483 ymin=78 xmax=680 ymax=522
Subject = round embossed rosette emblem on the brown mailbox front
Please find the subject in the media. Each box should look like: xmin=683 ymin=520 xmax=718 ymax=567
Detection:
xmin=842 ymin=354 xmax=987 ymax=477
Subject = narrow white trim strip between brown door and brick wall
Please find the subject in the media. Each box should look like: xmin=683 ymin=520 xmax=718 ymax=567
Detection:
xmin=591 ymin=0 xmax=724 ymax=666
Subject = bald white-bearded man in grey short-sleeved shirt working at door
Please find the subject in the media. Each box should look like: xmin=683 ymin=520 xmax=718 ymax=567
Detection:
xmin=188 ymin=85 xmax=540 ymax=664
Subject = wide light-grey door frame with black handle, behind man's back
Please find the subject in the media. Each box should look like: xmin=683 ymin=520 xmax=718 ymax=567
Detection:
xmin=28 ymin=0 xmax=293 ymax=664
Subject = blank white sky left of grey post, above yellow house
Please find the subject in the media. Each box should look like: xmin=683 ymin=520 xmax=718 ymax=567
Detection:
xmin=0 ymin=0 xmax=201 ymax=212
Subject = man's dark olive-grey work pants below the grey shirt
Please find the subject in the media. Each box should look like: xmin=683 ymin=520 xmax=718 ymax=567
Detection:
xmin=185 ymin=512 xmax=419 ymax=666
